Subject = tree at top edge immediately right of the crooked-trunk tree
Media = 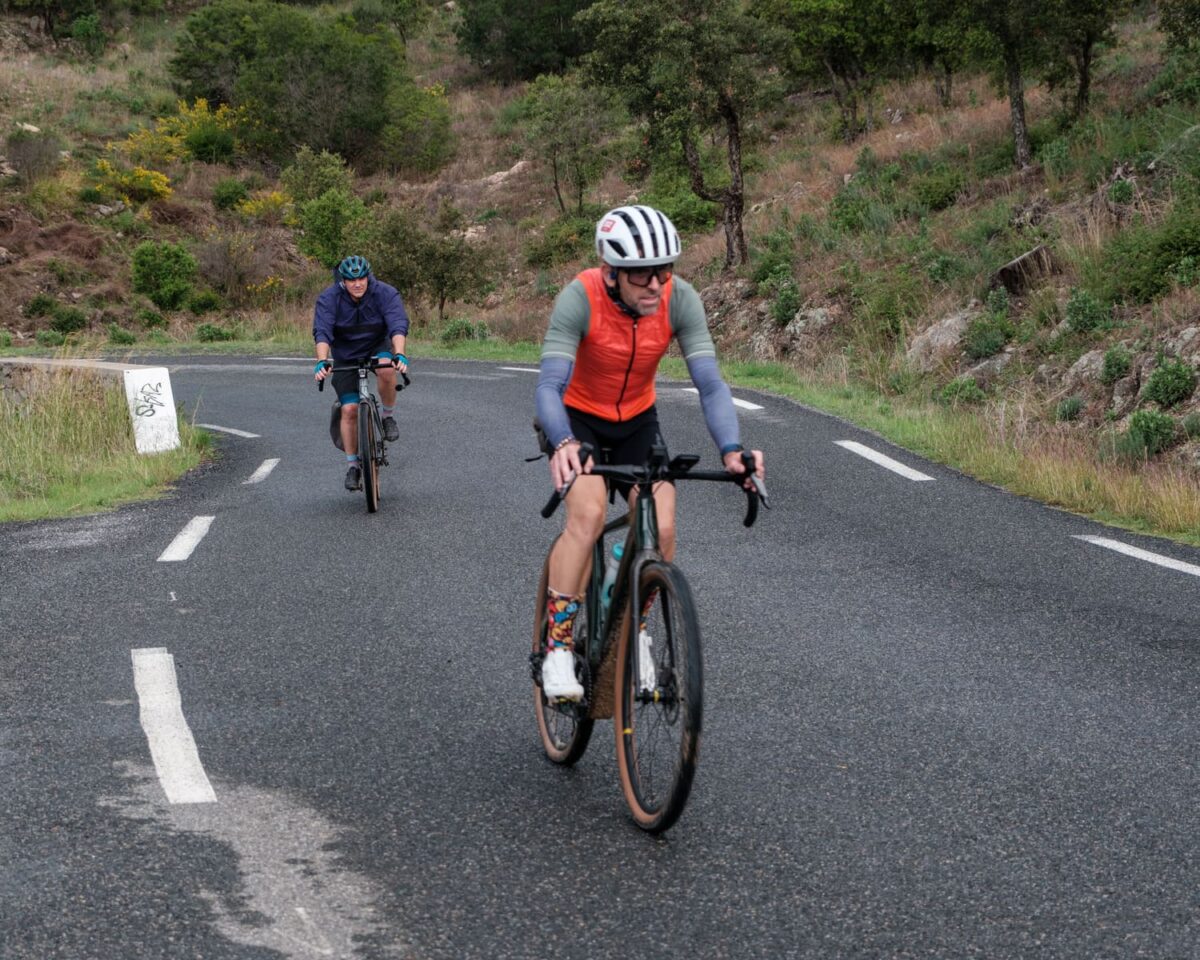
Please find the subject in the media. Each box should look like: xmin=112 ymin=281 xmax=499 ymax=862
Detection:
xmin=754 ymin=0 xmax=911 ymax=143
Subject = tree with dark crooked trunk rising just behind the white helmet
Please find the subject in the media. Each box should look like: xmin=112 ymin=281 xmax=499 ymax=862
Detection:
xmin=577 ymin=0 xmax=778 ymax=269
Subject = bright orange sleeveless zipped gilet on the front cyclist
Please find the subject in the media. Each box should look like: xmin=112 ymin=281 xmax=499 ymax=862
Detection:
xmin=563 ymin=266 xmax=671 ymax=421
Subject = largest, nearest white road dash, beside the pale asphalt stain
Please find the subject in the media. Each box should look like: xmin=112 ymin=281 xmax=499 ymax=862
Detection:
xmin=132 ymin=647 xmax=217 ymax=803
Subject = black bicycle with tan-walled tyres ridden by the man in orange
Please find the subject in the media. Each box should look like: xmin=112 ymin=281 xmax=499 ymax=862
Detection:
xmin=529 ymin=444 xmax=768 ymax=833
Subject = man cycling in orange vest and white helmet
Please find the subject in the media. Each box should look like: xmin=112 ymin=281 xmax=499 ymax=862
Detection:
xmin=535 ymin=205 xmax=763 ymax=700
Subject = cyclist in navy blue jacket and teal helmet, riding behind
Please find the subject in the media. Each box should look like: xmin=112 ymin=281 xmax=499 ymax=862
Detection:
xmin=312 ymin=256 xmax=408 ymax=490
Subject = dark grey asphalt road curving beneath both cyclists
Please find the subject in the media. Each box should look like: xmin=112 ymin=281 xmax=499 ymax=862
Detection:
xmin=0 ymin=359 xmax=1200 ymax=960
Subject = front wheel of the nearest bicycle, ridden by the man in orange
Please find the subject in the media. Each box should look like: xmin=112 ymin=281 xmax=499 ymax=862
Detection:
xmin=614 ymin=563 xmax=704 ymax=833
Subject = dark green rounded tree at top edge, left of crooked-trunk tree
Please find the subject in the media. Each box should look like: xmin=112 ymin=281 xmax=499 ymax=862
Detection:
xmin=456 ymin=0 xmax=593 ymax=83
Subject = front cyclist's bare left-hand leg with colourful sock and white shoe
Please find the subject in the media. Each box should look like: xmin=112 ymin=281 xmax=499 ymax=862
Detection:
xmin=541 ymin=476 xmax=606 ymax=700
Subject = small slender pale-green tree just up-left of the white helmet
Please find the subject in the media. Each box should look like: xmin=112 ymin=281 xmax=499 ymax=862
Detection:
xmin=524 ymin=74 xmax=617 ymax=214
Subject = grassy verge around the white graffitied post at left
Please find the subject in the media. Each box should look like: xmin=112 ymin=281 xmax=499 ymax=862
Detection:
xmin=0 ymin=371 xmax=208 ymax=522
